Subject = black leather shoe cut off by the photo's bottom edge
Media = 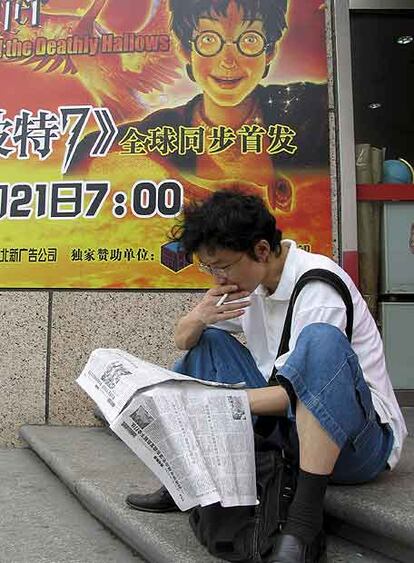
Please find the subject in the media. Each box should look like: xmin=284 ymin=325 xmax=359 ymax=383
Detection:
xmin=269 ymin=532 xmax=328 ymax=563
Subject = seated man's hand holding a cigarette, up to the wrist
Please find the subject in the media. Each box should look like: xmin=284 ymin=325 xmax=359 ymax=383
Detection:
xmin=188 ymin=285 xmax=250 ymax=327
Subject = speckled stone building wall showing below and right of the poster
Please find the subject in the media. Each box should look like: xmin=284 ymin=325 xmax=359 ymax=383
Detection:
xmin=0 ymin=2 xmax=339 ymax=446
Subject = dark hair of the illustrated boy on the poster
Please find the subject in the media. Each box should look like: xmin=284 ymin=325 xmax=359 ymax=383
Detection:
xmin=170 ymin=0 xmax=288 ymax=52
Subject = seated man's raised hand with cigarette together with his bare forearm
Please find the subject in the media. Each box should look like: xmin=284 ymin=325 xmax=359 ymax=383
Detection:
xmin=175 ymin=285 xmax=250 ymax=350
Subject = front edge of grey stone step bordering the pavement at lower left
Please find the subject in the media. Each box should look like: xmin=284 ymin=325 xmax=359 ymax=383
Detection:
xmin=19 ymin=426 xmax=178 ymax=563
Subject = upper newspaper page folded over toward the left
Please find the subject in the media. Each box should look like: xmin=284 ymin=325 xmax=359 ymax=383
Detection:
xmin=76 ymin=348 xmax=244 ymax=423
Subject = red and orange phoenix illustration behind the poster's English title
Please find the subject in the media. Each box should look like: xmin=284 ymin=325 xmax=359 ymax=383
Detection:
xmin=0 ymin=0 xmax=181 ymax=122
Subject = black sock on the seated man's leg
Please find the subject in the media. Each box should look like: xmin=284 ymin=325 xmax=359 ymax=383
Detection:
xmin=283 ymin=469 xmax=329 ymax=543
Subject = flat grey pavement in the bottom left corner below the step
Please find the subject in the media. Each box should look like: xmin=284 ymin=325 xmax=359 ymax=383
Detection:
xmin=0 ymin=448 xmax=143 ymax=563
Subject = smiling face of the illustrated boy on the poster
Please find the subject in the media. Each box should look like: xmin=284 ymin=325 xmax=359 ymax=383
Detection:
xmin=190 ymin=0 xmax=271 ymax=107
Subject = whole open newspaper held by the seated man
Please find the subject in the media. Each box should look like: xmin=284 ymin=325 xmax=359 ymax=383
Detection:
xmin=77 ymin=349 xmax=257 ymax=510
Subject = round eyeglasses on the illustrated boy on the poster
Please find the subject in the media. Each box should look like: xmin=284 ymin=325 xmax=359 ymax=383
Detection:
xmin=190 ymin=30 xmax=270 ymax=57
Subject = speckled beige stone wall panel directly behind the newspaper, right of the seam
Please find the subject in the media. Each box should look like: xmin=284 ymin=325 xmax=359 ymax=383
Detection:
xmin=49 ymin=291 xmax=199 ymax=425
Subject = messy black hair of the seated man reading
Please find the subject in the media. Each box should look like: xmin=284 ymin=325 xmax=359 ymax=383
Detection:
xmin=170 ymin=190 xmax=282 ymax=259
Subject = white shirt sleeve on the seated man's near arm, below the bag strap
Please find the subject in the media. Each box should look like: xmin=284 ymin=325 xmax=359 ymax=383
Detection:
xmin=275 ymin=281 xmax=347 ymax=368
